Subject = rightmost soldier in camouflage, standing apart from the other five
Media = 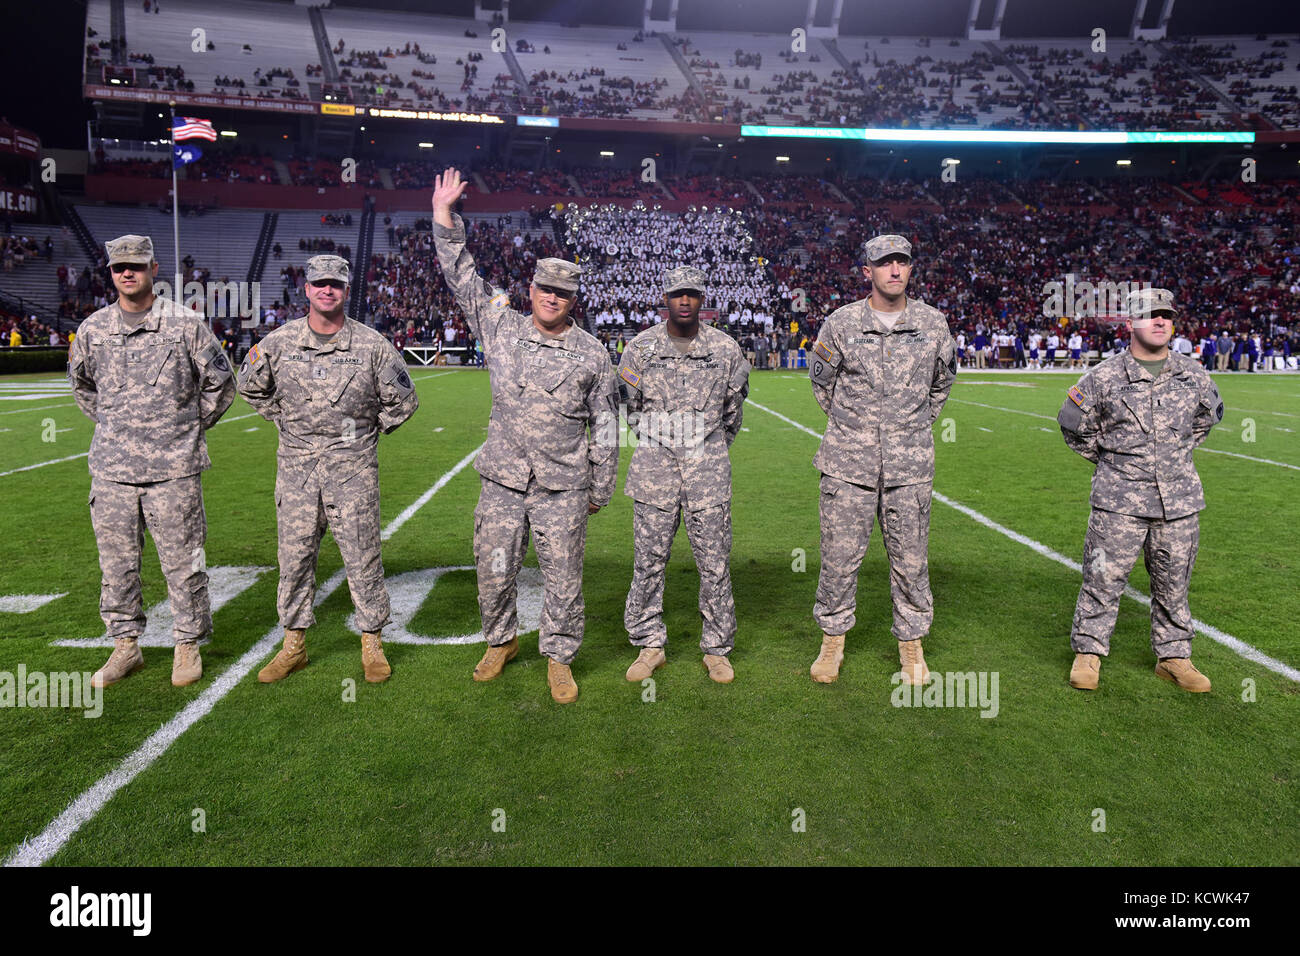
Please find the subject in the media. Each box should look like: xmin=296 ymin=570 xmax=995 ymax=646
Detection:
xmin=1057 ymin=289 xmax=1223 ymax=692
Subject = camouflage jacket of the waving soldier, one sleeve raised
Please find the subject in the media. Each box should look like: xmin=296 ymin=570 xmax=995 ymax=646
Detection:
xmin=433 ymin=216 xmax=619 ymax=507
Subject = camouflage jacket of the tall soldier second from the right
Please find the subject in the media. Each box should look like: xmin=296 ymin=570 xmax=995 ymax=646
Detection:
xmin=809 ymin=298 xmax=957 ymax=488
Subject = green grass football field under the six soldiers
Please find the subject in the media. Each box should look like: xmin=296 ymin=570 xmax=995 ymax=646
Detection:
xmin=0 ymin=369 xmax=1300 ymax=865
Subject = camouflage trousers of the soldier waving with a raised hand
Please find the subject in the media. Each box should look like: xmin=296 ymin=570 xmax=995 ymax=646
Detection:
xmin=475 ymin=476 xmax=590 ymax=663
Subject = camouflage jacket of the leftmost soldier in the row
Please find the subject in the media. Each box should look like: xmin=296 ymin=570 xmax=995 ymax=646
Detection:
xmin=68 ymin=297 xmax=235 ymax=484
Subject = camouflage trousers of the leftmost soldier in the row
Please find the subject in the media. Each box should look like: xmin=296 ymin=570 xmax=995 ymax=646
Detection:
xmin=90 ymin=475 xmax=212 ymax=641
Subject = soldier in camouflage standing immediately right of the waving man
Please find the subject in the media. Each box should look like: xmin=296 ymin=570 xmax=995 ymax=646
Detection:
xmin=619 ymin=267 xmax=749 ymax=684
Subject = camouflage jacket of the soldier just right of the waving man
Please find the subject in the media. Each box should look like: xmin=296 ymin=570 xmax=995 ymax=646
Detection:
xmin=619 ymin=323 xmax=749 ymax=511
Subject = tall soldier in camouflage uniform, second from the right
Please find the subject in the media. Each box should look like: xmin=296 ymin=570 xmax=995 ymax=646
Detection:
xmin=809 ymin=235 xmax=957 ymax=684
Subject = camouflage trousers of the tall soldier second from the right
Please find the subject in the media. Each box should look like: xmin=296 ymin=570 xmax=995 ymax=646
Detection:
xmin=813 ymin=475 xmax=935 ymax=641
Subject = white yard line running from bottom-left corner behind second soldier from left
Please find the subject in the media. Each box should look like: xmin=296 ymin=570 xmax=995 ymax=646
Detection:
xmin=4 ymin=445 xmax=482 ymax=866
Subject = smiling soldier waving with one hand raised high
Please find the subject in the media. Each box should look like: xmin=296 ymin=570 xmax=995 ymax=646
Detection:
xmin=433 ymin=169 xmax=619 ymax=704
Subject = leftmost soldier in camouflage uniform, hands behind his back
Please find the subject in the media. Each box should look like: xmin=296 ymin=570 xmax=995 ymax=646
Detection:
xmin=68 ymin=235 xmax=235 ymax=687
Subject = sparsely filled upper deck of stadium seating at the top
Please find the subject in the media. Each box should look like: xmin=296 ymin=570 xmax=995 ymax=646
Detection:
xmin=87 ymin=0 xmax=1300 ymax=130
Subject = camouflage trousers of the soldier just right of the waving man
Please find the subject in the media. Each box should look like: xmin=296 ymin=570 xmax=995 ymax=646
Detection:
xmin=623 ymin=489 xmax=736 ymax=657
